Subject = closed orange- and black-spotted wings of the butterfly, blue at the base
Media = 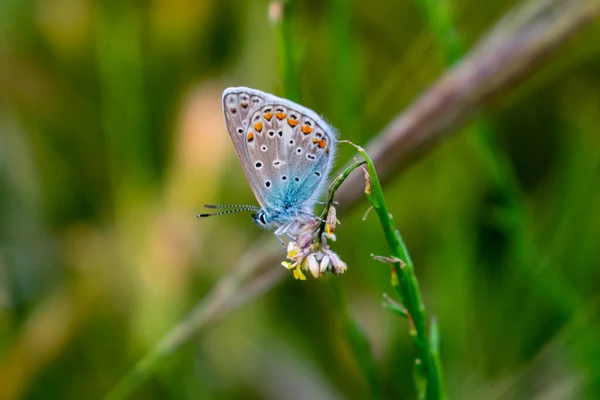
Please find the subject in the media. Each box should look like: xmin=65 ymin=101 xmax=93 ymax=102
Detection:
xmin=224 ymin=88 xmax=335 ymax=212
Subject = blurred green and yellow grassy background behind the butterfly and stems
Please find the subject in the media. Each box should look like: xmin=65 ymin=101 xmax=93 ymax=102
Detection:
xmin=0 ymin=0 xmax=600 ymax=399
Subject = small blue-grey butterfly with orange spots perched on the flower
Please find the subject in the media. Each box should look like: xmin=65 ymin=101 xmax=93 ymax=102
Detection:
xmin=198 ymin=87 xmax=337 ymax=240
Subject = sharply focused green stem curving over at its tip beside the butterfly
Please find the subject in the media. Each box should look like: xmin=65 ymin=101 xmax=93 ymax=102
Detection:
xmin=341 ymin=140 xmax=446 ymax=399
